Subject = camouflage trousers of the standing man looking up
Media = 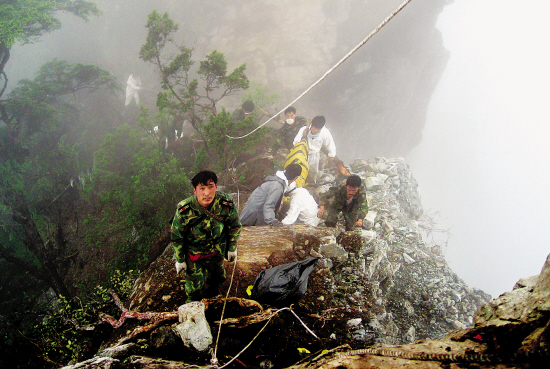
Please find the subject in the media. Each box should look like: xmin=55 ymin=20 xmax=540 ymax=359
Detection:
xmin=185 ymin=254 xmax=226 ymax=302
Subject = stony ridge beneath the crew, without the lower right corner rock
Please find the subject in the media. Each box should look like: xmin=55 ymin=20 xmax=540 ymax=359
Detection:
xmin=60 ymin=158 xmax=496 ymax=368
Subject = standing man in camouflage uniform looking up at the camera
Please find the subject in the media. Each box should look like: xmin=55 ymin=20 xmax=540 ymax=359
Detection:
xmin=171 ymin=170 xmax=241 ymax=302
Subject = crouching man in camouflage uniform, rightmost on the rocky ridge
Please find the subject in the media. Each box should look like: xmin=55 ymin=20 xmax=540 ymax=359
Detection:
xmin=317 ymin=175 xmax=369 ymax=231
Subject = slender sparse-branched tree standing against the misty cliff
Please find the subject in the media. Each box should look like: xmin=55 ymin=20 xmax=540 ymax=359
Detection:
xmin=140 ymin=11 xmax=249 ymax=157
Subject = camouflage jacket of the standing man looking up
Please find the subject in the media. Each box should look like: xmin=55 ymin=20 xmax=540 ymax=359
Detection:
xmin=171 ymin=192 xmax=241 ymax=263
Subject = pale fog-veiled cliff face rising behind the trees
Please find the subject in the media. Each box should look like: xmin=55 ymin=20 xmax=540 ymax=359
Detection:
xmin=12 ymin=0 xmax=452 ymax=160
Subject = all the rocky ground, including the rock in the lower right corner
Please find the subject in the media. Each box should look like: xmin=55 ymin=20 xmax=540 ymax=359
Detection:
xmin=61 ymin=158 xmax=550 ymax=368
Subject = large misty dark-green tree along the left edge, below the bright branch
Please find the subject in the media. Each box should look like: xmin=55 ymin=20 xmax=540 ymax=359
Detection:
xmin=0 ymin=59 xmax=120 ymax=297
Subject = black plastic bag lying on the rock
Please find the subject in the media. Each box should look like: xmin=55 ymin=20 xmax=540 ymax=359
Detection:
xmin=251 ymin=258 xmax=319 ymax=307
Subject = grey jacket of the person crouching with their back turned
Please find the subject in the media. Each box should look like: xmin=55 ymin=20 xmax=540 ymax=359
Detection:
xmin=240 ymin=176 xmax=285 ymax=226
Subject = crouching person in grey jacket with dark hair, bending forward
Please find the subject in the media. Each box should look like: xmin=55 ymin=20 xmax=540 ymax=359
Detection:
xmin=241 ymin=164 xmax=302 ymax=227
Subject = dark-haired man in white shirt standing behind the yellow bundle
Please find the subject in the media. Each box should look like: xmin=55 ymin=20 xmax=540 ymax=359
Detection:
xmin=293 ymin=115 xmax=336 ymax=182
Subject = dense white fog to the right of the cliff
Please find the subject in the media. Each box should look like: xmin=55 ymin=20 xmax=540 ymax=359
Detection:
xmin=407 ymin=0 xmax=550 ymax=297
